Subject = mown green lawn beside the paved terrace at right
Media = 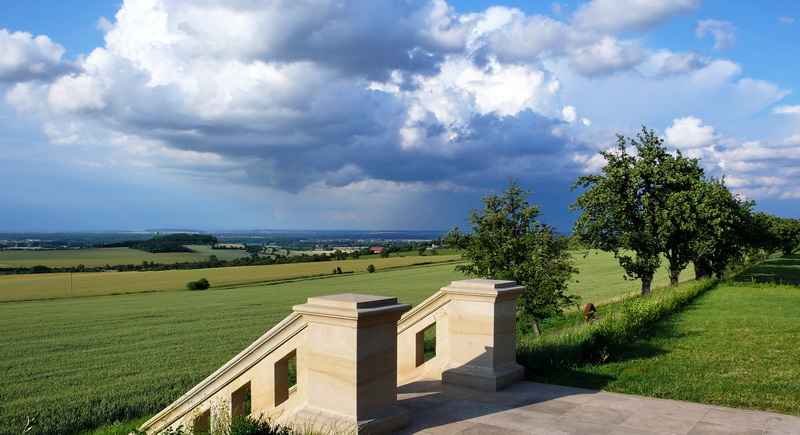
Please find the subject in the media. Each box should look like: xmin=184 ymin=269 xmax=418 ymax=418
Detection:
xmin=531 ymin=256 xmax=800 ymax=415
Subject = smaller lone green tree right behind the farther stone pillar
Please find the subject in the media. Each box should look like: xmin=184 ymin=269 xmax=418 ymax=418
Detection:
xmin=451 ymin=180 xmax=578 ymax=334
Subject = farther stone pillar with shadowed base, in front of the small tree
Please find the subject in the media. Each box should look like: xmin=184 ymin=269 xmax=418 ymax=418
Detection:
xmin=442 ymin=279 xmax=525 ymax=391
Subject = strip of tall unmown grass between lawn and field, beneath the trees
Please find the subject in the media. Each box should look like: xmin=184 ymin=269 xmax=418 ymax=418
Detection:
xmin=517 ymin=279 xmax=717 ymax=371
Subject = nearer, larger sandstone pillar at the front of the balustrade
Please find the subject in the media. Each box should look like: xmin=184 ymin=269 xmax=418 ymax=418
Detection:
xmin=294 ymin=294 xmax=411 ymax=433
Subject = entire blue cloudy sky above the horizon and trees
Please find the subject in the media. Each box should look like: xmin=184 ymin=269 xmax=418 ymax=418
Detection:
xmin=0 ymin=0 xmax=800 ymax=232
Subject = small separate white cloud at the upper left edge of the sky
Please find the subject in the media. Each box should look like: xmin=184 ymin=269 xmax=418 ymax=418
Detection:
xmin=0 ymin=29 xmax=78 ymax=83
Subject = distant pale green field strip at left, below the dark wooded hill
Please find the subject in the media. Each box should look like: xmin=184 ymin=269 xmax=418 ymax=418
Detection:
xmin=0 ymin=246 xmax=249 ymax=267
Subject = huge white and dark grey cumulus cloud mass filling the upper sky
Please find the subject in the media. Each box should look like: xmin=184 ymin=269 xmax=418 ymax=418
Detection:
xmin=0 ymin=0 xmax=793 ymax=216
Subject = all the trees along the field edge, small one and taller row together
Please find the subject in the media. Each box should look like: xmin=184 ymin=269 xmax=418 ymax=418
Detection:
xmin=445 ymin=127 xmax=800 ymax=333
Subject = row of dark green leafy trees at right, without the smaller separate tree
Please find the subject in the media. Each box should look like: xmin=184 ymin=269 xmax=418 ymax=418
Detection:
xmin=571 ymin=127 xmax=800 ymax=293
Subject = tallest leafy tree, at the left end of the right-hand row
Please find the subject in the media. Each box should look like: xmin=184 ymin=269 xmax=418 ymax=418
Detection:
xmin=570 ymin=127 xmax=703 ymax=294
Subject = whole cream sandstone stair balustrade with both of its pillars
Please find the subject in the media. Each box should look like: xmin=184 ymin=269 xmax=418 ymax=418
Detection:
xmin=141 ymin=279 xmax=524 ymax=434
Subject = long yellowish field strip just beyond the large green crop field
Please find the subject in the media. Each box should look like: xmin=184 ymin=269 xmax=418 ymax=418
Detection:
xmin=0 ymin=255 xmax=459 ymax=302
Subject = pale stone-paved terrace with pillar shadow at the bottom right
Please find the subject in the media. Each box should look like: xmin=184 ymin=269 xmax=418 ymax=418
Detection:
xmin=397 ymin=381 xmax=800 ymax=435
